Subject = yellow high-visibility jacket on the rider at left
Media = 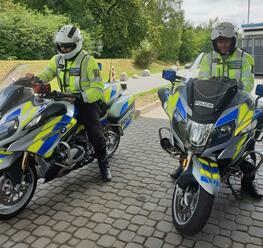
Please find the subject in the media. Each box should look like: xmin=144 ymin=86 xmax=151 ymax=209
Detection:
xmin=37 ymin=50 xmax=104 ymax=103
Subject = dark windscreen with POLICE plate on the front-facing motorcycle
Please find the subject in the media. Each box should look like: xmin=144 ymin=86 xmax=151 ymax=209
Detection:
xmin=187 ymin=80 xmax=238 ymax=124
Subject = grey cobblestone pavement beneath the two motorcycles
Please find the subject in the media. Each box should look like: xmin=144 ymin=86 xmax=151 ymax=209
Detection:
xmin=0 ymin=118 xmax=263 ymax=248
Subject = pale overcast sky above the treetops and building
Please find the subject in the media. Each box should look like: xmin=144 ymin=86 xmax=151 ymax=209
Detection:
xmin=182 ymin=0 xmax=263 ymax=26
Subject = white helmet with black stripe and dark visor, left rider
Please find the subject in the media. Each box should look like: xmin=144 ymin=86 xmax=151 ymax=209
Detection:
xmin=54 ymin=25 xmax=83 ymax=59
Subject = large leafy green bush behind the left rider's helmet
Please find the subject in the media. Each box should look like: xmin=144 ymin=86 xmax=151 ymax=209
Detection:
xmin=0 ymin=5 xmax=97 ymax=60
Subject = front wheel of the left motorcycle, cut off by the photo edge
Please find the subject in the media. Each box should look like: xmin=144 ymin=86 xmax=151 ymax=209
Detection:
xmin=0 ymin=165 xmax=37 ymax=220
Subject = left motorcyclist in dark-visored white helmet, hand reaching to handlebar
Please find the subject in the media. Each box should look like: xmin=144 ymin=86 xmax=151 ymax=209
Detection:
xmin=26 ymin=25 xmax=112 ymax=182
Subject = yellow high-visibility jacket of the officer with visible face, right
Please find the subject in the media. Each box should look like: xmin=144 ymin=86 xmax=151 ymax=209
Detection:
xmin=199 ymin=48 xmax=255 ymax=92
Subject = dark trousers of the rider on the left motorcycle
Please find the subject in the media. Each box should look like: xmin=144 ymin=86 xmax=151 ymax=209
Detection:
xmin=76 ymin=102 xmax=107 ymax=161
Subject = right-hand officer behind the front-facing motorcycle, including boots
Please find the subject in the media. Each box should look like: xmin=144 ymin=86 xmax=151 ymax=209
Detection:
xmin=170 ymin=22 xmax=263 ymax=198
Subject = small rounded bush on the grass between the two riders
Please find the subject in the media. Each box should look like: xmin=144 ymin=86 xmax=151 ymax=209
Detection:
xmin=133 ymin=39 xmax=156 ymax=68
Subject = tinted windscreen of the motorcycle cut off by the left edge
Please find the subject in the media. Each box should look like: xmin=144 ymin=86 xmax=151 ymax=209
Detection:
xmin=0 ymin=84 xmax=34 ymax=114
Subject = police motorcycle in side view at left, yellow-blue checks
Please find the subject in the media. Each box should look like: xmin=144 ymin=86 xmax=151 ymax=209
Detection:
xmin=0 ymin=66 xmax=135 ymax=219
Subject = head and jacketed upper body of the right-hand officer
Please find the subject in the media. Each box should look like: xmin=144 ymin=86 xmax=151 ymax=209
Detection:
xmin=199 ymin=22 xmax=254 ymax=92
